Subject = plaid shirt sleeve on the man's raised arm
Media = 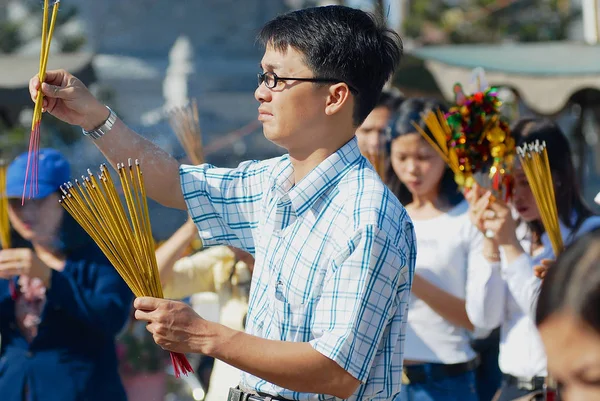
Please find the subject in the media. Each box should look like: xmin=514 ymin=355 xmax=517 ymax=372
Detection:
xmin=179 ymin=161 xmax=272 ymax=254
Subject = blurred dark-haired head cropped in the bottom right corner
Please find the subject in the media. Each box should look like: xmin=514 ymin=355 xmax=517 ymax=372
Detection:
xmin=535 ymin=230 xmax=600 ymax=401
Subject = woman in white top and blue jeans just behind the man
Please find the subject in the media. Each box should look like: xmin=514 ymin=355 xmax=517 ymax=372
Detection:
xmin=387 ymin=99 xmax=503 ymax=401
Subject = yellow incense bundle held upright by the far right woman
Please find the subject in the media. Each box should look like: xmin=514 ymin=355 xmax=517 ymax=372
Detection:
xmin=517 ymin=141 xmax=563 ymax=255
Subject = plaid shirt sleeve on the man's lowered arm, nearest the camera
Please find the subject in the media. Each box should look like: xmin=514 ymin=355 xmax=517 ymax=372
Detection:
xmin=310 ymin=226 xmax=415 ymax=383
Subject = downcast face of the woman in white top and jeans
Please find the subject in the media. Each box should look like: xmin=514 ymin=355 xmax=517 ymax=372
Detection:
xmin=390 ymin=133 xmax=446 ymax=197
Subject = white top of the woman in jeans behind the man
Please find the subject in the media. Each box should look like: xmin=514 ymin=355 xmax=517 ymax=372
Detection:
xmin=404 ymin=202 xmax=504 ymax=364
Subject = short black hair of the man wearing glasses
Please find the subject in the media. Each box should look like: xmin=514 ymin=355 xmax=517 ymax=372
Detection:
xmin=258 ymin=6 xmax=402 ymax=126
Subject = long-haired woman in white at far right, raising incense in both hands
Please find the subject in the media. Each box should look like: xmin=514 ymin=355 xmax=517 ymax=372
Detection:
xmin=470 ymin=119 xmax=600 ymax=401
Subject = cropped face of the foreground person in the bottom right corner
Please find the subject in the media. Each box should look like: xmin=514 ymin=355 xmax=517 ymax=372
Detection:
xmin=539 ymin=311 xmax=600 ymax=401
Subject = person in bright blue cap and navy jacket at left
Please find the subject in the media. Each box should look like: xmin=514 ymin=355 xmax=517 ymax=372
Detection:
xmin=0 ymin=149 xmax=133 ymax=401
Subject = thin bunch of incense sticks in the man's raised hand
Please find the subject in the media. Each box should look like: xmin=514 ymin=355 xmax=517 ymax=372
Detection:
xmin=21 ymin=0 xmax=60 ymax=203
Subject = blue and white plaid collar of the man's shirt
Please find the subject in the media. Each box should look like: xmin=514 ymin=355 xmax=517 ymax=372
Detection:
xmin=274 ymin=137 xmax=362 ymax=216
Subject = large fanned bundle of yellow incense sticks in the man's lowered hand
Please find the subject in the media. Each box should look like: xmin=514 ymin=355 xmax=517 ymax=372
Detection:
xmin=60 ymin=159 xmax=193 ymax=377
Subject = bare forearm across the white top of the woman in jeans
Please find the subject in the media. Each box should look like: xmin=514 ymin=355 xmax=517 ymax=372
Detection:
xmin=412 ymin=274 xmax=473 ymax=331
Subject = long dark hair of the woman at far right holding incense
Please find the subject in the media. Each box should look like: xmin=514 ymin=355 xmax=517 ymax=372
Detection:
xmin=512 ymin=118 xmax=594 ymax=240
